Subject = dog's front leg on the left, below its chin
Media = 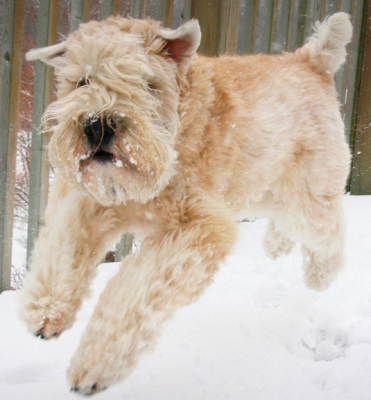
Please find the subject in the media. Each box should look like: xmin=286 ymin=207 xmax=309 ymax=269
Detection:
xmin=20 ymin=178 xmax=123 ymax=339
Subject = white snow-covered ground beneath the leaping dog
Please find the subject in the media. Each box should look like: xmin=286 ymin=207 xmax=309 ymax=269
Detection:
xmin=0 ymin=196 xmax=371 ymax=400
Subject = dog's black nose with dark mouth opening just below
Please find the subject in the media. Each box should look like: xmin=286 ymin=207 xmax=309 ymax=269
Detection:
xmin=84 ymin=117 xmax=116 ymax=162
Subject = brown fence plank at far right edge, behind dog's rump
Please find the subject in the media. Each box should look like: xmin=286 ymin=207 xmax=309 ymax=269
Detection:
xmin=350 ymin=1 xmax=371 ymax=195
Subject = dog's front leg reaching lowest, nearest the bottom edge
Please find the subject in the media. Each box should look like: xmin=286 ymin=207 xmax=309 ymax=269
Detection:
xmin=68 ymin=197 xmax=236 ymax=395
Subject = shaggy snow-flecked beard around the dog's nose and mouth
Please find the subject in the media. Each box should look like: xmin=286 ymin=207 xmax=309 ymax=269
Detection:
xmin=49 ymin=111 xmax=176 ymax=206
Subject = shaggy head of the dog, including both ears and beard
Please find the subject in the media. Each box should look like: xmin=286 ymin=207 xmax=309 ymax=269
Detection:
xmin=27 ymin=18 xmax=201 ymax=205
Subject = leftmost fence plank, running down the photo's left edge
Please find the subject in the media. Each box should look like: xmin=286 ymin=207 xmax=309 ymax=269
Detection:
xmin=0 ymin=0 xmax=25 ymax=293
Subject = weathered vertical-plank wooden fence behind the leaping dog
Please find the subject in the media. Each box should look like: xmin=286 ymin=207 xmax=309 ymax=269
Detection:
xmin=0 ymin=0 xmax=371 ymax=291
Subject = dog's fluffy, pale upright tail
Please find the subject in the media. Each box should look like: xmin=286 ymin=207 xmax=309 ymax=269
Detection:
xmin=295 ymin=12 xmax=353 ymax=75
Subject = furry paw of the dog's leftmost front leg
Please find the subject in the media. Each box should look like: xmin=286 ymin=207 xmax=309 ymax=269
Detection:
xmin=20 ymin=297 xmax=75 ymax=339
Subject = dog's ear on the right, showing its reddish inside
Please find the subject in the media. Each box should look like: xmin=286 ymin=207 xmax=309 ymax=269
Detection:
xmin=160 ymin=19 xmax=201 ymax=68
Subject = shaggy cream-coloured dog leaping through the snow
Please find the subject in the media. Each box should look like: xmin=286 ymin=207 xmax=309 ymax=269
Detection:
xmin=21 ymin=13 xmax=352 ymax=394
